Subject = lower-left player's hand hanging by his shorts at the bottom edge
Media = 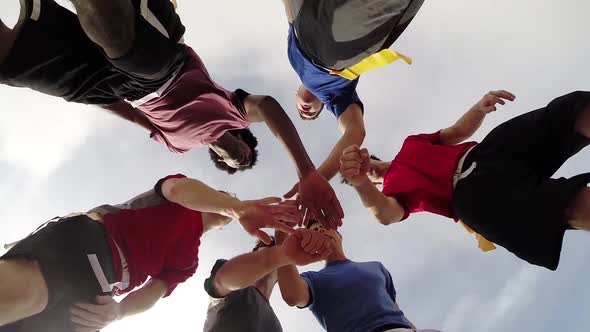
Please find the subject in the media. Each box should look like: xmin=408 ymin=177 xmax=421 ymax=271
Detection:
xmin=70 ymin=296 xmax=122 ymax=332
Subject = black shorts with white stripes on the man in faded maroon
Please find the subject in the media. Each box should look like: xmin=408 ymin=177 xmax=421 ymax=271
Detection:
xmin=0 ymin=0 xmax=186 ymax=104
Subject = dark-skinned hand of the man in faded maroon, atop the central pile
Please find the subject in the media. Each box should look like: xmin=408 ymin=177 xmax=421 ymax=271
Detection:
xmin=284 ymin=170 xmax=344 ymax=229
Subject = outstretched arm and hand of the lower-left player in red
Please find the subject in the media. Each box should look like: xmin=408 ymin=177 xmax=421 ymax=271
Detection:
xmin=161 ymin=178 xmax=298 ymax=244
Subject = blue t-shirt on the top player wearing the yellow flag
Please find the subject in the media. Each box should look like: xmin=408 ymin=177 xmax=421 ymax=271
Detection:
xmin=287 ymin=24 xmax=363 ymax=118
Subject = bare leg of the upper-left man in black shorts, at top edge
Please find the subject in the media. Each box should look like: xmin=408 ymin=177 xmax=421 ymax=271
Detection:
xmin=71 ymin=0 xmax=135 ymax=59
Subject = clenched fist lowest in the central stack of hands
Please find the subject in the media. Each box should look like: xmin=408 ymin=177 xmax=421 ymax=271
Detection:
xmin=281 ymin=228 xmax=333 ymax=265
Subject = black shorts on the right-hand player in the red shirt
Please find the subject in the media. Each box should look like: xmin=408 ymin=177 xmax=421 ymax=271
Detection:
xmin=453 ymin=92 xmax=590 ymax=270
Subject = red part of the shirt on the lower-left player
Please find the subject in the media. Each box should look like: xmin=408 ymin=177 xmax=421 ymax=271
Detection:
xmin=103 ymin=174 xmax=203 ymax=296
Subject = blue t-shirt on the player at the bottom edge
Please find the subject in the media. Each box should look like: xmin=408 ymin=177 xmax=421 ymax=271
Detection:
xmin=301 ymin=260 xmax=412 ymax=332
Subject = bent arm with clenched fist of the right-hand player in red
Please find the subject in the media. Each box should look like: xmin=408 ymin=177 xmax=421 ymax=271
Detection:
xmin=340 ymin=145 xmax=405 ymax=225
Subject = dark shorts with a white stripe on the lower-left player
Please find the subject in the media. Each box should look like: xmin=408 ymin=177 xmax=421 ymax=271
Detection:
xmin=0 ymin=215 xmax=116 ymax=332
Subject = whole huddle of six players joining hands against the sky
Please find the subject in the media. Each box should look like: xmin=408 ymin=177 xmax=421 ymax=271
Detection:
xmin=0 ymin=0 xmax=590 ymax=332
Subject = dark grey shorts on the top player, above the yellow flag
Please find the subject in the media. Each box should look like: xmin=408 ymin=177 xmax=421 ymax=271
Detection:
xmin=288 ymin=0 xmax=425 ymax=70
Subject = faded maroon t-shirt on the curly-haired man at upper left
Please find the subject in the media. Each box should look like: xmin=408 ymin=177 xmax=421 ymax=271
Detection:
xmin=138 ymin=47 xmax=250 ymax=153
